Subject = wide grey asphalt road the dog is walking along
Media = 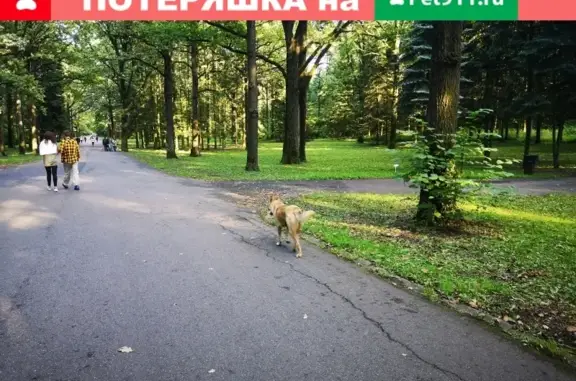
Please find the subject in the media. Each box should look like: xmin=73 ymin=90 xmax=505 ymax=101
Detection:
xmin=0 ymin=147 xmax=576 ymax=381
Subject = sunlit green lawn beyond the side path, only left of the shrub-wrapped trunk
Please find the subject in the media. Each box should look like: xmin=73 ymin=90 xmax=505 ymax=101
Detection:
xmin=129 ymin=140 xmax=408 ymax=181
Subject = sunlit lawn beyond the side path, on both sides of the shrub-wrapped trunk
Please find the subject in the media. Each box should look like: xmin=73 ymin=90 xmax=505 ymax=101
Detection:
xmin=129 ymin=140 xmax=576 ymax=181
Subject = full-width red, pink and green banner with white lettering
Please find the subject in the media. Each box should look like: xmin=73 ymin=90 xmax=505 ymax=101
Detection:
xmin=0 ymin=0 xmax=576 ymax=21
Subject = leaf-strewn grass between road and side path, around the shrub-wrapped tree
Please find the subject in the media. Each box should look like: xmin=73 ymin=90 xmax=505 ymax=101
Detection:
xmin=290 ymin=193 xmax=576 ymax=354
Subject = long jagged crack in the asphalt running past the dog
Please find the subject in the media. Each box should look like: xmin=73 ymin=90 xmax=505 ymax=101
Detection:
xmin=218 ymin=221 xmax=466 ymax=381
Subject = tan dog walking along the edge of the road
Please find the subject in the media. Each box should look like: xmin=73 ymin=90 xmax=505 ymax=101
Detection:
xmin=268 ymin=194 xmax=316 ymax=258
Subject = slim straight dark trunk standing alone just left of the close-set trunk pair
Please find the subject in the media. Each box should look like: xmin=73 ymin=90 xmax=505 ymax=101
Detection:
xmin=246 ymin=21 xmax=260 ymax=171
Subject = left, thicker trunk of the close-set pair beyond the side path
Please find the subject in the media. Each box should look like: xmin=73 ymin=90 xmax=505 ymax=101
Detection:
xmin=281 ymin=21 xmax=304 ymax=164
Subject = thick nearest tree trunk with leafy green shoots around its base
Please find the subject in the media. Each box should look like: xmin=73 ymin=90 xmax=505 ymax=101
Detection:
xmin=417 ymin=21 xmax=462 ymax=223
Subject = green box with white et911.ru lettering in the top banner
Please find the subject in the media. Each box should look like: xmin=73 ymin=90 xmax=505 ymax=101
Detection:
xmin=375 ymin=0 xmax=518 ymax=21
